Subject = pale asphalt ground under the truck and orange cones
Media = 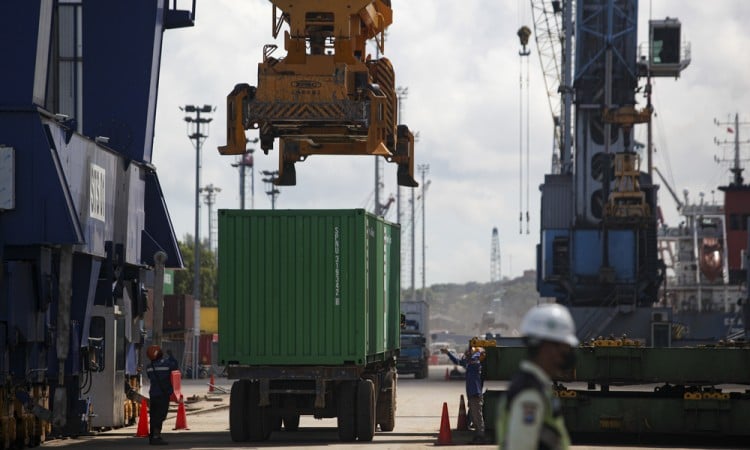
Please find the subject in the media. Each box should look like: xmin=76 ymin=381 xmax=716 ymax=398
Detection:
xmin=42 ymin=365 xmax=750 ymax=450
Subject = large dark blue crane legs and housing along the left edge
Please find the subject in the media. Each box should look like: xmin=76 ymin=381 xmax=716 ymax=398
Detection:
xmin=0 ymin=0 xmax=195 ymax=447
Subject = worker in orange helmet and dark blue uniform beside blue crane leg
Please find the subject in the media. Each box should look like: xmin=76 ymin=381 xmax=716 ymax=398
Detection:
xmin=146 ymin=345 xmax=177 ymax=445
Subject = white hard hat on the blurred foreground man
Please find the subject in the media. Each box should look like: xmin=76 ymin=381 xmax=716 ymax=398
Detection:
xmin=521 ymin=303 xmax=578 ymax=347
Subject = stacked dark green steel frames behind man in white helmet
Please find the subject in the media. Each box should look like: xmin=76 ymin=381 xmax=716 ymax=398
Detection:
xmin=484 ymin=339 xmax=750 ymax=444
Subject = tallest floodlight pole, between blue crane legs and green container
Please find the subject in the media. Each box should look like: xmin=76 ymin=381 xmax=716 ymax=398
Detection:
xmin=180 ymin=105 xmax=213 ymax=378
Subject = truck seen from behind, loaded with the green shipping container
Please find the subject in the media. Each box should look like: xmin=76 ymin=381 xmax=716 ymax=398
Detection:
xmin=218 ymin=209 xmax=400 ymax=442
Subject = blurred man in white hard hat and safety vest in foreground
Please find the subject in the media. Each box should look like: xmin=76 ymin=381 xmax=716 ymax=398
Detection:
xmin=496 ymin=303 xmax=578 ymax=450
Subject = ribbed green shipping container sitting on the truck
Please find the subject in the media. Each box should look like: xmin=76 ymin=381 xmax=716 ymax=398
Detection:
xmin=219 ymin=209 xmax=400 ymax=366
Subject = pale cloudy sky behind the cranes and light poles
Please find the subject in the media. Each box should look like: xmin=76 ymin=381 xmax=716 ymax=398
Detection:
xmin=153 ymin=0 xmax=750 ymax=286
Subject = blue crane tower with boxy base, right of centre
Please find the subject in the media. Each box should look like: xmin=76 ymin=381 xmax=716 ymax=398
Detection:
xmin=537 ymin=0 xmax=669 ymax=338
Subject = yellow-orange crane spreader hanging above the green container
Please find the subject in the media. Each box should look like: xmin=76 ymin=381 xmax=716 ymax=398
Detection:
xmin=219 ymin=0 xmax=417 ymax=187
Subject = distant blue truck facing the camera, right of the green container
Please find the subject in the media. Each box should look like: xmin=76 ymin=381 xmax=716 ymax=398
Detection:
xmin=396 ymin=301 xmax=430 ymax=379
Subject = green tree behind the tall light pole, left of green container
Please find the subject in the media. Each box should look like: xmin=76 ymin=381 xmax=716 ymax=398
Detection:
xmin=174 ymin=234 xmax=219 ymax=306
